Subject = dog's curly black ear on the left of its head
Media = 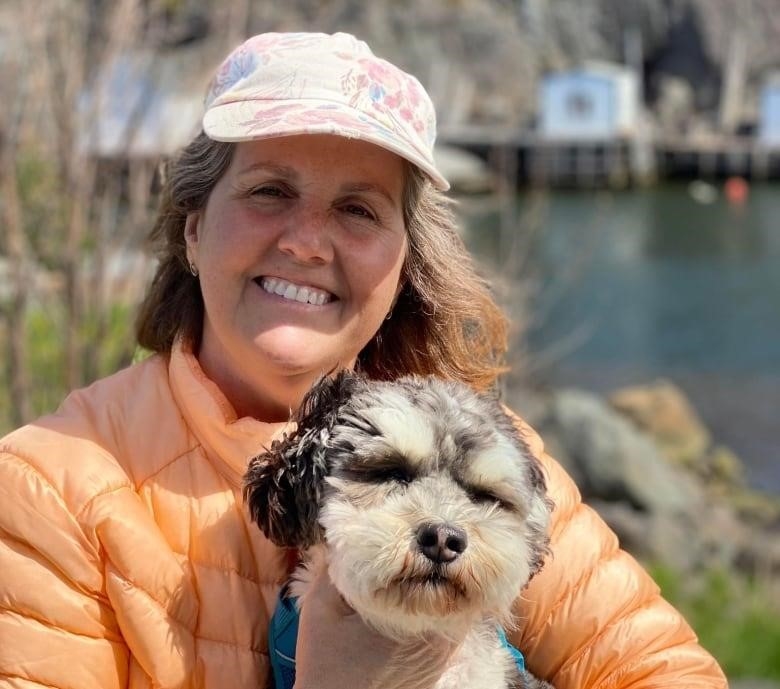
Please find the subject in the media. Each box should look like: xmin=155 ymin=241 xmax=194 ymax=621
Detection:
xmin=244 ymin=371 xmax=361 ymax=548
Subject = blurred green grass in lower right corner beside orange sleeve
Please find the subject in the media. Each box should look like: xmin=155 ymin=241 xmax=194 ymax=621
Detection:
xmin=650 ymin=566 xmax=780 ymax=680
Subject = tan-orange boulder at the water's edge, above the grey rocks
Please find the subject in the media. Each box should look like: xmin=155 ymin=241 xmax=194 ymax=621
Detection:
xmin=609 ymin=380 xmax=711 ymax=468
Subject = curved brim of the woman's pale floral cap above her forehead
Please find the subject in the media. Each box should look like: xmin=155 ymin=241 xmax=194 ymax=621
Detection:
xmin=203 ymin=100 xmax=450 ymax=191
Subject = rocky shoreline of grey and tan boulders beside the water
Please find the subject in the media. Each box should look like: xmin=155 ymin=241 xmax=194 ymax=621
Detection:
xmin=507 ymin=380 xmax=780 ymax=580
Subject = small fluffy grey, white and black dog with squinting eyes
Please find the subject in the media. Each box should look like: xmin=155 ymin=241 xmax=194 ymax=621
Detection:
xmin=244 ymin=372 xmax=552 ymax=689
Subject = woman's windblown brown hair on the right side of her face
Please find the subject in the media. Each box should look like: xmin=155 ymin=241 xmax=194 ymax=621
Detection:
xmin=359 ymin=165 xmax=507 ymax=390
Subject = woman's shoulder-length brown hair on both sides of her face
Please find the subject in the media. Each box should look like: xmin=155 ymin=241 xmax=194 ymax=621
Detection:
xmin=136 ymin=133 xmax=507 ymax=390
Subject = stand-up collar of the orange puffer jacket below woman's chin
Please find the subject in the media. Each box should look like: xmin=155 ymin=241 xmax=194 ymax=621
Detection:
xmin=168 ymin=342 xmax=290 ymax=487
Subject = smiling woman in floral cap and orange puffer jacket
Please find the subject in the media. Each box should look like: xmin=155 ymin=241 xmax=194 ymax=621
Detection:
xmin=0 ymin=34 xmax=725 ymax=689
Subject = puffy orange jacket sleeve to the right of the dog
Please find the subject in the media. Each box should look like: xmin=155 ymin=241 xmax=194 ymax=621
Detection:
xmin=513 ymin=424 xmax=727 ymax=689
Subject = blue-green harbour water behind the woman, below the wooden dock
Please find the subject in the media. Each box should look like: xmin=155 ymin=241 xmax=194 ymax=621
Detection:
xmin=462 ymin=185 xmax=780 ymax=493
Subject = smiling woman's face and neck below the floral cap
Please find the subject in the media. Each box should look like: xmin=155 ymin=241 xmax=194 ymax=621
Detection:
xmin=185 ymin=135 xmax=407 ymax=421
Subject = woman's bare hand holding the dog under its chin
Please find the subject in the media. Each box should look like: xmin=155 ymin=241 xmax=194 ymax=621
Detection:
xmin=295 ymin=571 xmax=455 ymax=689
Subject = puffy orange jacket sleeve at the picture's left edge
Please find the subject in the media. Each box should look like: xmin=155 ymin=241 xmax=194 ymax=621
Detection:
xmin=0 ymin=452 xmax=129 ymax=689
